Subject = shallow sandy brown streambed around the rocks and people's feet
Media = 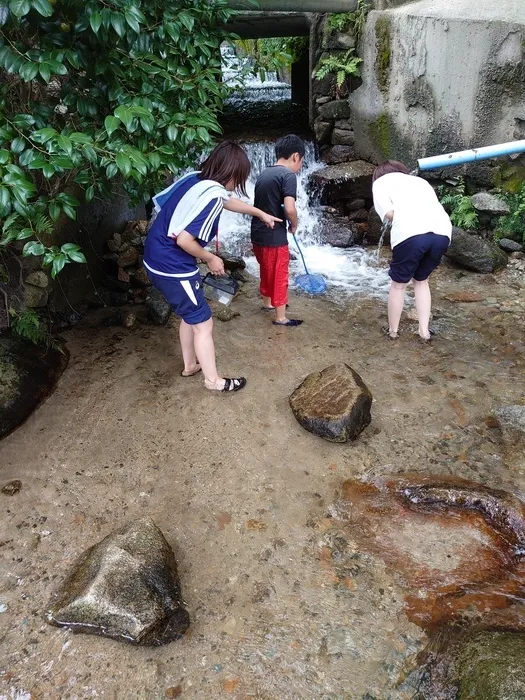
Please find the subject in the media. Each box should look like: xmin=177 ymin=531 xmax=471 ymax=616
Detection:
xmin=0 ymin=266 xmax=525 ymax=700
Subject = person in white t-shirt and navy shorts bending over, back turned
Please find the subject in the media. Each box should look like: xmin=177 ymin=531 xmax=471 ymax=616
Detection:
xmin=372 ymin=160 xmax=452 ymax=342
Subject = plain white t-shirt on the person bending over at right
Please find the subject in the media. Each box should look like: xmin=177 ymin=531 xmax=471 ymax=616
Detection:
xmin=372 ymin=173 xmax=452 ymax=248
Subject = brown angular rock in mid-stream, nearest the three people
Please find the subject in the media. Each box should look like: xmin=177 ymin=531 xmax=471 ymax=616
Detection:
xmin=290 ymin=364 xmax=372 ymax=442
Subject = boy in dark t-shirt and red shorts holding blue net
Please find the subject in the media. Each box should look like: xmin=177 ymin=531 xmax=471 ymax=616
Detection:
xmin=251 ymin=135 xmax=306 ymax=327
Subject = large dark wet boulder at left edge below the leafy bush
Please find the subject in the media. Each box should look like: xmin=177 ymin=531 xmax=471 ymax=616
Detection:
xmin=0 ymin=338 xmax=69 ymax=439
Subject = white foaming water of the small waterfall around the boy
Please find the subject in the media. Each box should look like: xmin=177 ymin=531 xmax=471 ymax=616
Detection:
xmin=219 ymin=142 xmax=390 ymax=301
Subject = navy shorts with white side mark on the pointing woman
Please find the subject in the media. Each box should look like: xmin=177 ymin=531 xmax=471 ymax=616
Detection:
xmin=147 ymin=270 xmax=211 ymax=326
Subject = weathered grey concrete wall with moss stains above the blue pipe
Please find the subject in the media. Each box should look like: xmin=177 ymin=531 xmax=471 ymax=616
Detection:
xmin=350 ymin=0 xmax=525 ymax=183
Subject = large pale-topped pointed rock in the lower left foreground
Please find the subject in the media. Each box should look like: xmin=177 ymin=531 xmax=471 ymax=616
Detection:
xmin=46 ymin=518 xmax=189 ymax=646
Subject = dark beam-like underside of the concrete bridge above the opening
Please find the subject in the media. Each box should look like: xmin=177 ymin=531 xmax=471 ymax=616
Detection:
xmin=228 ymin=12 xmax=310 ymax=39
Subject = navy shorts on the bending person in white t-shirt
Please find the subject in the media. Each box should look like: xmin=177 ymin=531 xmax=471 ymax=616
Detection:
xmin=388 ymin=233 xmax=450 ymax=284
